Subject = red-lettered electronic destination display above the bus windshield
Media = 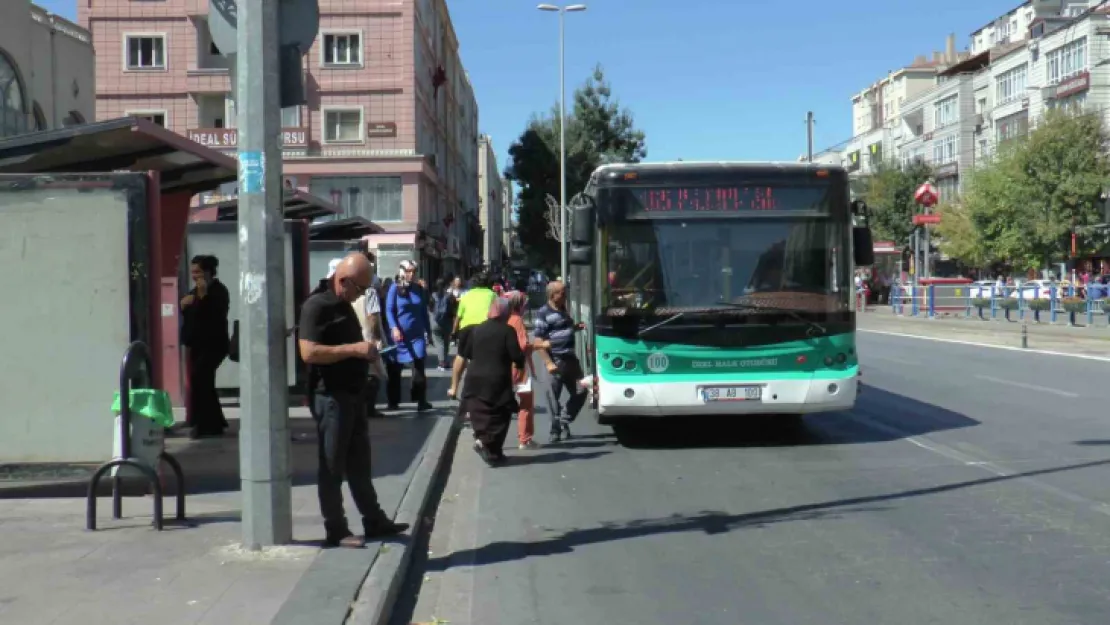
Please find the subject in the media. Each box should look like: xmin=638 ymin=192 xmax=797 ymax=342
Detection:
xmin=628 ymin=187 xmax=828 ymax=213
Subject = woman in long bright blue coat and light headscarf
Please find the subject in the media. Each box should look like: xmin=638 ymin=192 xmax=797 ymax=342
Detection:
xmin=385 ymin=261 xmax=435 ymax=411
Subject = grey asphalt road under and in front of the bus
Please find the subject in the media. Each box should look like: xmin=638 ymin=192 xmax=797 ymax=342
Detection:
xmin=394 ymin=334 xmax=1110 ymax=625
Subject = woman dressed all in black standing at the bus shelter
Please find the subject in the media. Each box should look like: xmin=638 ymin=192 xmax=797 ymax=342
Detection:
xmin=181 ymin=255 xmax=231 ymax=437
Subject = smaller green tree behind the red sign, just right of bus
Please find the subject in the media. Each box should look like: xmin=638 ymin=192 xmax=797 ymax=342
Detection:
xmin=862 ymin=161 xmax=932 ymax=246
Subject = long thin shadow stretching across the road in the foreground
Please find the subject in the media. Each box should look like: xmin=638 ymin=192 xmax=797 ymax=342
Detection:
xmin=427 ymin=460 xmax=1110 ymax=572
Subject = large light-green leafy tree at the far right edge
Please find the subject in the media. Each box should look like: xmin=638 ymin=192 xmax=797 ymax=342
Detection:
xmin=940 ymin=110 xmax=1110 ymax=270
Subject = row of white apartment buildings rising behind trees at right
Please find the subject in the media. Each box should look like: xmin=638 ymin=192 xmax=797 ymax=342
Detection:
xmin=815 ymin=0 xmax=1110 ymax=200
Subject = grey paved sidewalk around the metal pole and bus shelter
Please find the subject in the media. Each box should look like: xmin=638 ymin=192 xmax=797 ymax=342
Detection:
xmin=0 ymin=369 xmax=457 ymax=625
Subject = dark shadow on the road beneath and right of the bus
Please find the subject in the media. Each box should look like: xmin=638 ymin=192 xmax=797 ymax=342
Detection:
xmin=614 ymin=385 xmax=979 ymax=450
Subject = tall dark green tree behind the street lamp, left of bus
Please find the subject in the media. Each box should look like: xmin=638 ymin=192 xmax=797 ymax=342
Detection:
xmin=505 ymin=65 xmax=647 ymax=269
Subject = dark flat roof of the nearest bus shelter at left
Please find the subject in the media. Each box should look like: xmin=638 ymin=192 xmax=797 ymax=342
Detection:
xmin=0 ymin=117 xmax=238 ymax=193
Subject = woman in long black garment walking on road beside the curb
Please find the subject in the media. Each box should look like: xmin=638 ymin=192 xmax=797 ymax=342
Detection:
xmin=460 ymin=298 xmax=524 ymax=466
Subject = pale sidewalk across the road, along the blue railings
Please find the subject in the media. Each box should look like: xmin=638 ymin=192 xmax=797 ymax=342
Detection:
xmin=856 ymin=306 xmax=1110 ymax=356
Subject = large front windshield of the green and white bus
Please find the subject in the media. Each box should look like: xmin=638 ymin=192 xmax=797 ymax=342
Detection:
xmin=602 ymin=216 xmax=851 ymax=314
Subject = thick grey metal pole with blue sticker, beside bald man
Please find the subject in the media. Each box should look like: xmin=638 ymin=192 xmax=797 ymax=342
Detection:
xmin=236 ymin=0 xmax=293 ymax=550
